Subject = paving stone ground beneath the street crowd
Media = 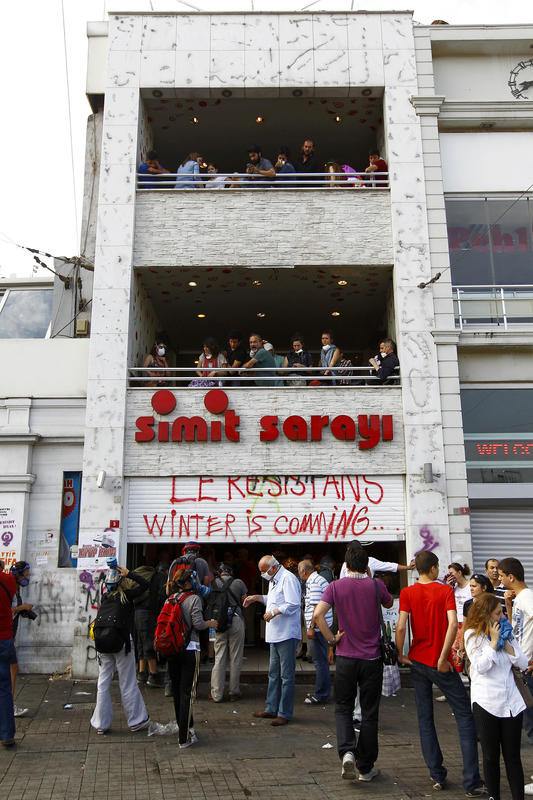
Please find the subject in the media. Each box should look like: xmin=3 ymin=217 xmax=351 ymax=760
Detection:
xmin=0 ymin=675 xmax=533 ymax=800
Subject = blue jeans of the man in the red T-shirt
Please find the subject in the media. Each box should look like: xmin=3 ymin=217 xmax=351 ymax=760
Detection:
xmin=411 ymin=661 xmax=481 ymax=792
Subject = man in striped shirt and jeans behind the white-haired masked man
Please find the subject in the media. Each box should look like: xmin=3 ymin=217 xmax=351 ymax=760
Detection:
xmin=298 ymin=559 xmax=333 ymax=706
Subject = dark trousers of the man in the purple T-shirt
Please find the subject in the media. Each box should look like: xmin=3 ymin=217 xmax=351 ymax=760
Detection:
xmin=335 ymin=656 xmax=383 ymax=774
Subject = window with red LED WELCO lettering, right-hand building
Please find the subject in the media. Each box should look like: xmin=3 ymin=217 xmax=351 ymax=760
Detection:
xmin=461 ymin=387 xmax=533 ymax=483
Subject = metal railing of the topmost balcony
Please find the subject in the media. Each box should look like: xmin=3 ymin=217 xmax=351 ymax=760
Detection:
xmin=137 ymin=172 xmax=389 ymax=192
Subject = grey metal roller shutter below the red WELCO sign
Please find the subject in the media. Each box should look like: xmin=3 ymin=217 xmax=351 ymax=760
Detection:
xmin=470 ymin=506 xmax=533 ymax=585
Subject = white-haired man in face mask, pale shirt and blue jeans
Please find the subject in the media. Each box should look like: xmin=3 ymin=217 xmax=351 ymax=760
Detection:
xmin=243 ymin=556 xmax=302 ymax=726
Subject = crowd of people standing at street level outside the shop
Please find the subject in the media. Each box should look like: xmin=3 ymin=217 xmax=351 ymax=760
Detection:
xmin=0 ymin=540 xmax=533 ymax=800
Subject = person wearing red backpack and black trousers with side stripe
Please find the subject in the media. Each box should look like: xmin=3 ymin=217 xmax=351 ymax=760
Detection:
xmin=164 ymin=559 xmax=218 ymax=750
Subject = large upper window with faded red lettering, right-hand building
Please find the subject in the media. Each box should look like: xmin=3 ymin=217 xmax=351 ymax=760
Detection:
xmin=446 ymin=195 xmax=533 ymax=286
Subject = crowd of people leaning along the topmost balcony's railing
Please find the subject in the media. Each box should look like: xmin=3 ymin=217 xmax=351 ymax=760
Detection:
xmin=139 ymin=138 xmax=388 ymax=189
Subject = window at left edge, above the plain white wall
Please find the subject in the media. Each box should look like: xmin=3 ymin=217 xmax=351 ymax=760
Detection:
xmin=0 ymin=289 xmax=53 ymax=339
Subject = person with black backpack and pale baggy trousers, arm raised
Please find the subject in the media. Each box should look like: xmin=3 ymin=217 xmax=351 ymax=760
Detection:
xmin=91 ymin=566 xmax=150 ymax=735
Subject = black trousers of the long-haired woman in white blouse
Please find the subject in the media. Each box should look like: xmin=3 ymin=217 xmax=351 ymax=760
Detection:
xmin=472 ymin=703 xmax=524 ymax=800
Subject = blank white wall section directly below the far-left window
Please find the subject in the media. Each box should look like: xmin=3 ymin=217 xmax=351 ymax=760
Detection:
xmin=0 ymin=338 xmax=89 ymax=397
